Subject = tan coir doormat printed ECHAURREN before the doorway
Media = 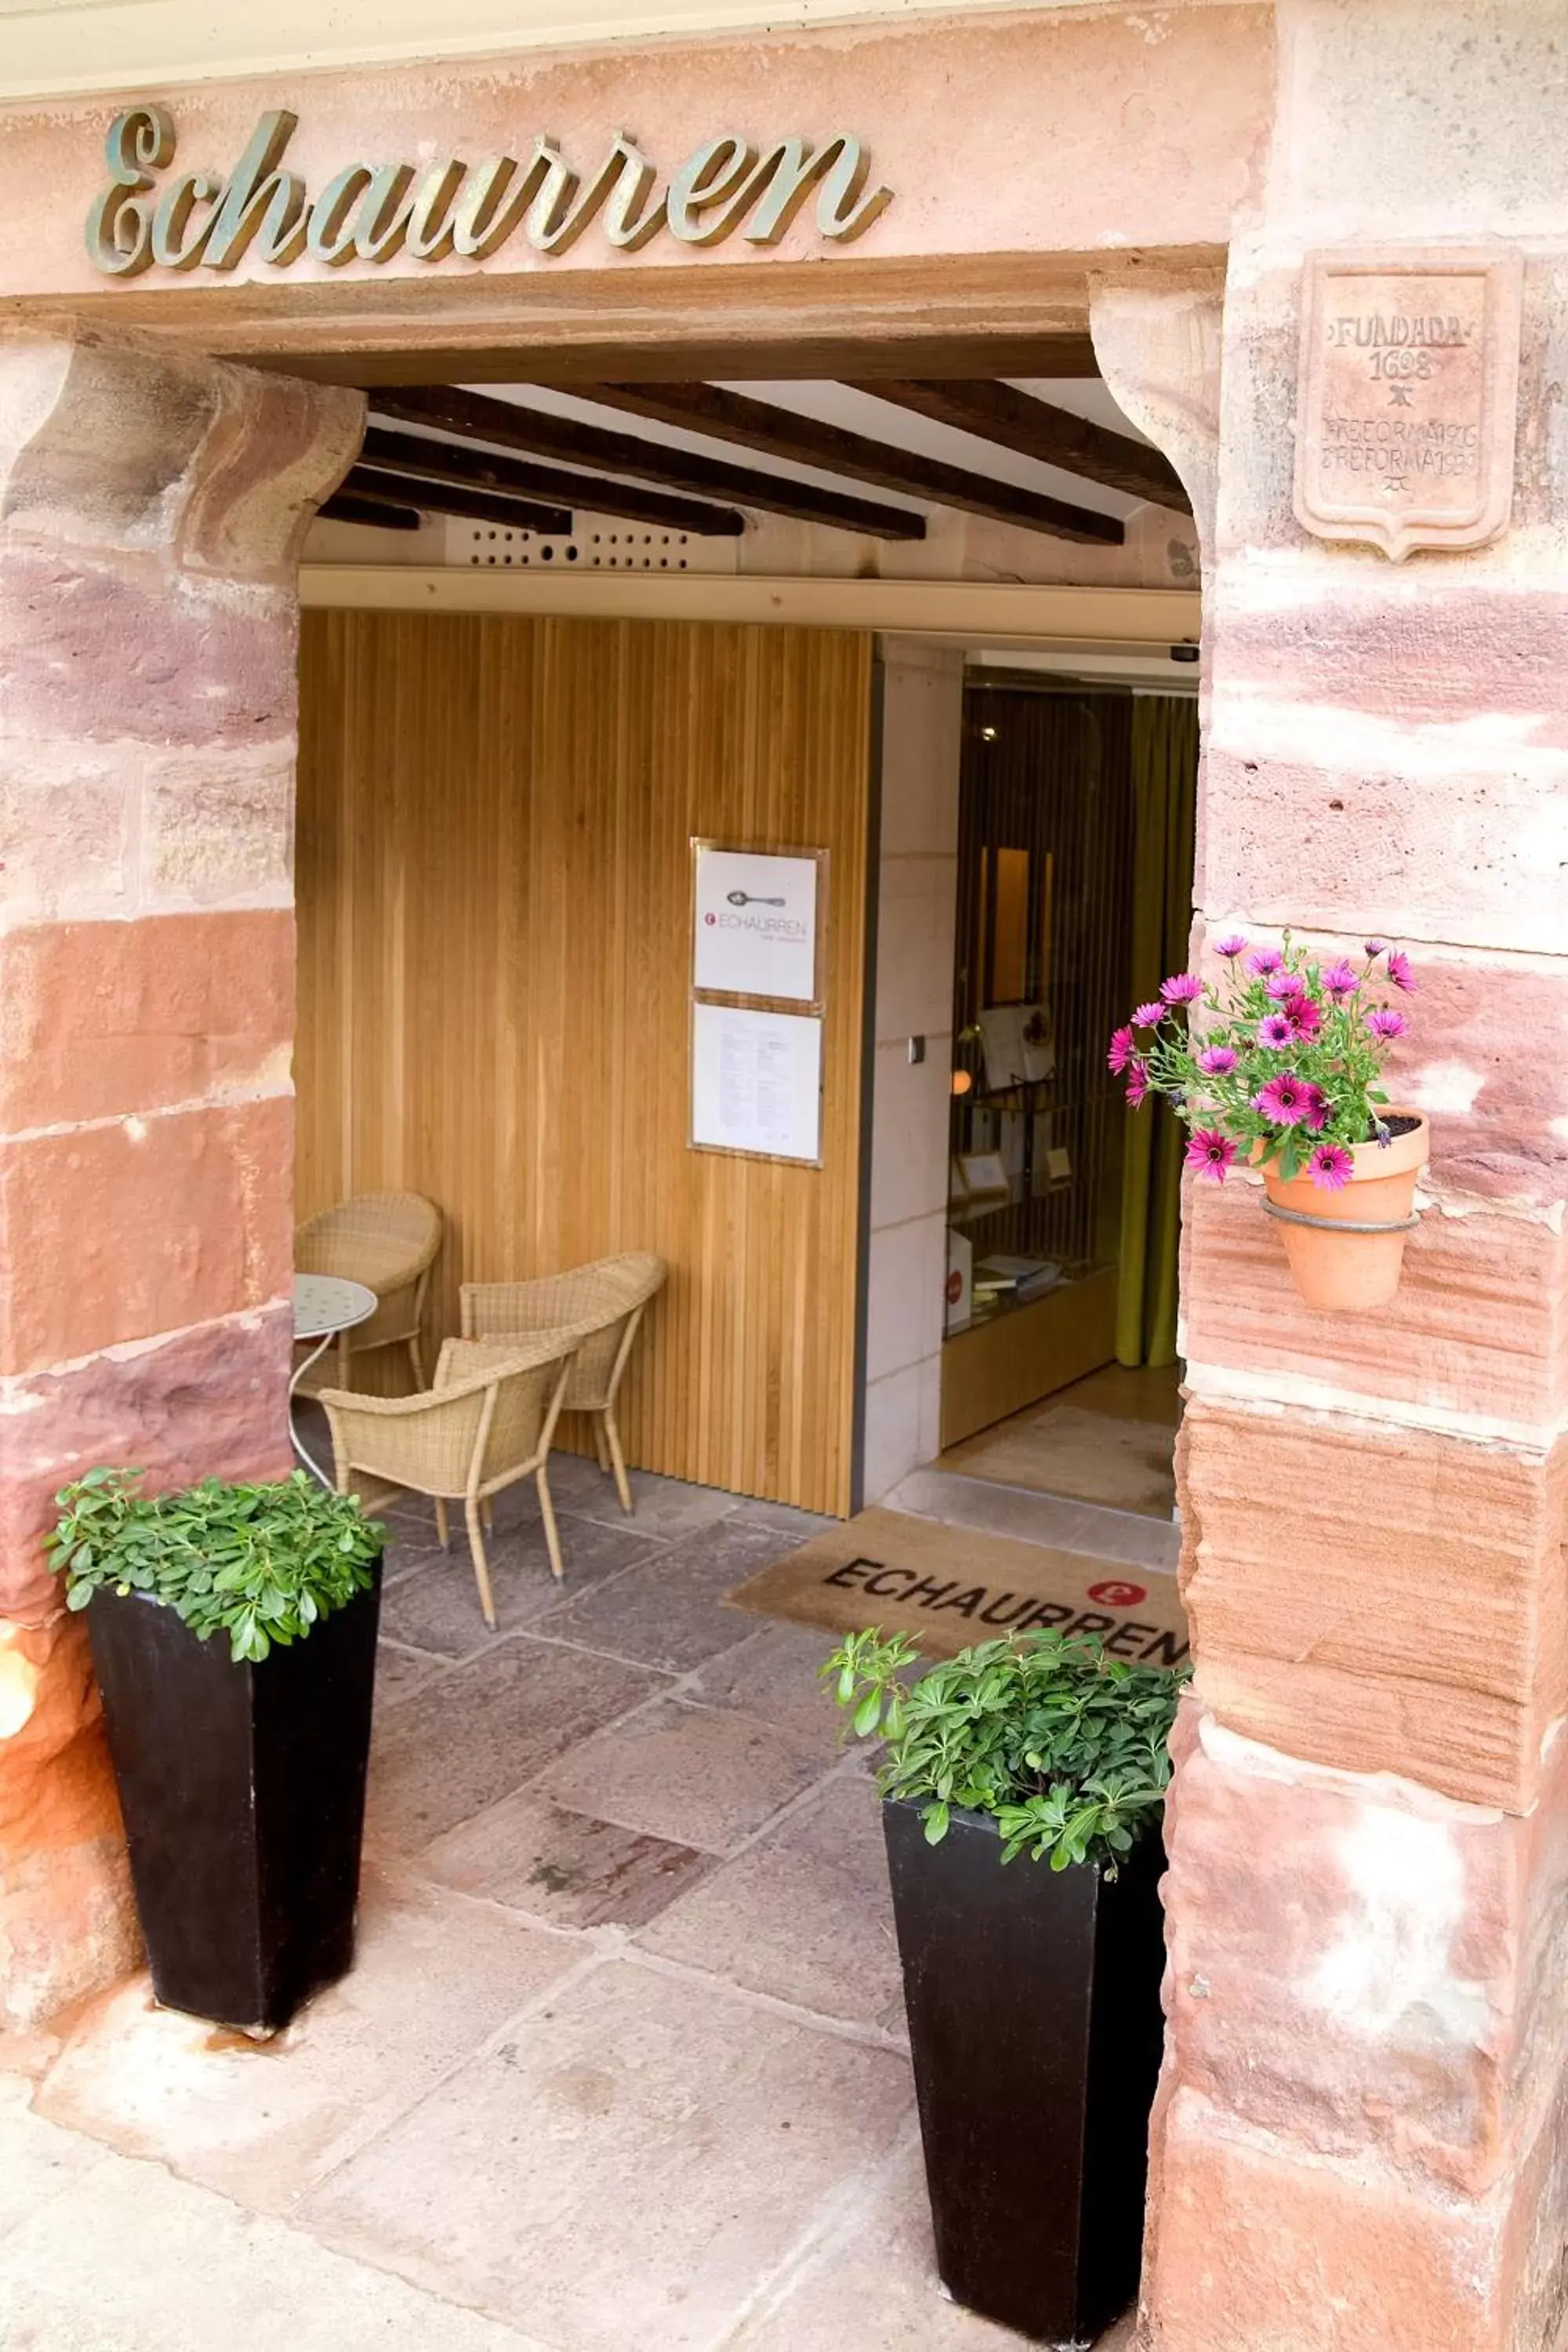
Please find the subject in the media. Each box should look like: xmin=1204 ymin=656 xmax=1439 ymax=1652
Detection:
xmin=727 ymin=1510 xmax=1187 ymax=1665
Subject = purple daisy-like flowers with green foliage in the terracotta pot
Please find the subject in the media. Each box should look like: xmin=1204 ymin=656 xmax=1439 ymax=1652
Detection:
xmin=1107 ymin=931 xmax=1415 ymax=1192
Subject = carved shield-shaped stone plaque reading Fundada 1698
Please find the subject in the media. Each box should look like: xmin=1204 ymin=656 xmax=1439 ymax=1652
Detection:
xmin=1295 ymin=245 xmax=1523 ymax=562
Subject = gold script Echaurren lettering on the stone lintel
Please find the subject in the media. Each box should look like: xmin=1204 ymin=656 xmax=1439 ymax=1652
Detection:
xmin=87 ymin=106 xmax=893 ymax=278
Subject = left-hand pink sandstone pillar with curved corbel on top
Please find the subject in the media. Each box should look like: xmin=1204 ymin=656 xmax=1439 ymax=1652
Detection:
xmin=0 ymin=329 xmax=362 ymax=2025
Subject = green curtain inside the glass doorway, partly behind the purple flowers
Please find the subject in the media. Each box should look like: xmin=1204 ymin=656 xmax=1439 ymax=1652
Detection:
xmin=1116 ymin=694 xmax=1199 ymax=1367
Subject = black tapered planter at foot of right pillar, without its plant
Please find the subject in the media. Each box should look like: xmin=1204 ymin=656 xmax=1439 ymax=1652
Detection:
xmin=881 ymin=1799 xmax=1166 ymax=2345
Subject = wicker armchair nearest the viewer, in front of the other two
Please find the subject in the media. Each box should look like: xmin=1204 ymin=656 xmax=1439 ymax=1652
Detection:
xmin=322 ymin=1329 xmax=583 ymax=1628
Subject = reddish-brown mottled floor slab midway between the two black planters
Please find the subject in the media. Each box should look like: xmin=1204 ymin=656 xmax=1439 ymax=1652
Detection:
xmin=419 ymin=1788 xmax=715 ymax=1929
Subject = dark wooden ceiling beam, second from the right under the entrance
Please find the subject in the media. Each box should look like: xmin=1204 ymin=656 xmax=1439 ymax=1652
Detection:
xmin=583 ymin=383 xmax=1126 ymax=548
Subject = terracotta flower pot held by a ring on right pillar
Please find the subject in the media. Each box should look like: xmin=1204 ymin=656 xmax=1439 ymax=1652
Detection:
xmin=1262 ymin=1110 xmax=1427 ymax=1312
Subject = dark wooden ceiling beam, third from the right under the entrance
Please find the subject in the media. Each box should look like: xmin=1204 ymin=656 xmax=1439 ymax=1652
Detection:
xmin=374 ymin=383 xmax=926 ymax=539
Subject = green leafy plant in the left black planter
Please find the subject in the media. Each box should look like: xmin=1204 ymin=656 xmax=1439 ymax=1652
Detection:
xmin=45 ymin=1470 xmax=386 ymax=1665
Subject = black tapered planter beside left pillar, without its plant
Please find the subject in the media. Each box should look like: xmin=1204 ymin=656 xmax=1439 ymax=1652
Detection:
xmin=87 ymin=1562 xmax=381 ymax=2030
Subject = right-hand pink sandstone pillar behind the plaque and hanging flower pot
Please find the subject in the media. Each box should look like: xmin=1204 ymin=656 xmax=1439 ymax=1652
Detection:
xmin=1095 ymin=0 xmax=1568 ymax=2352
